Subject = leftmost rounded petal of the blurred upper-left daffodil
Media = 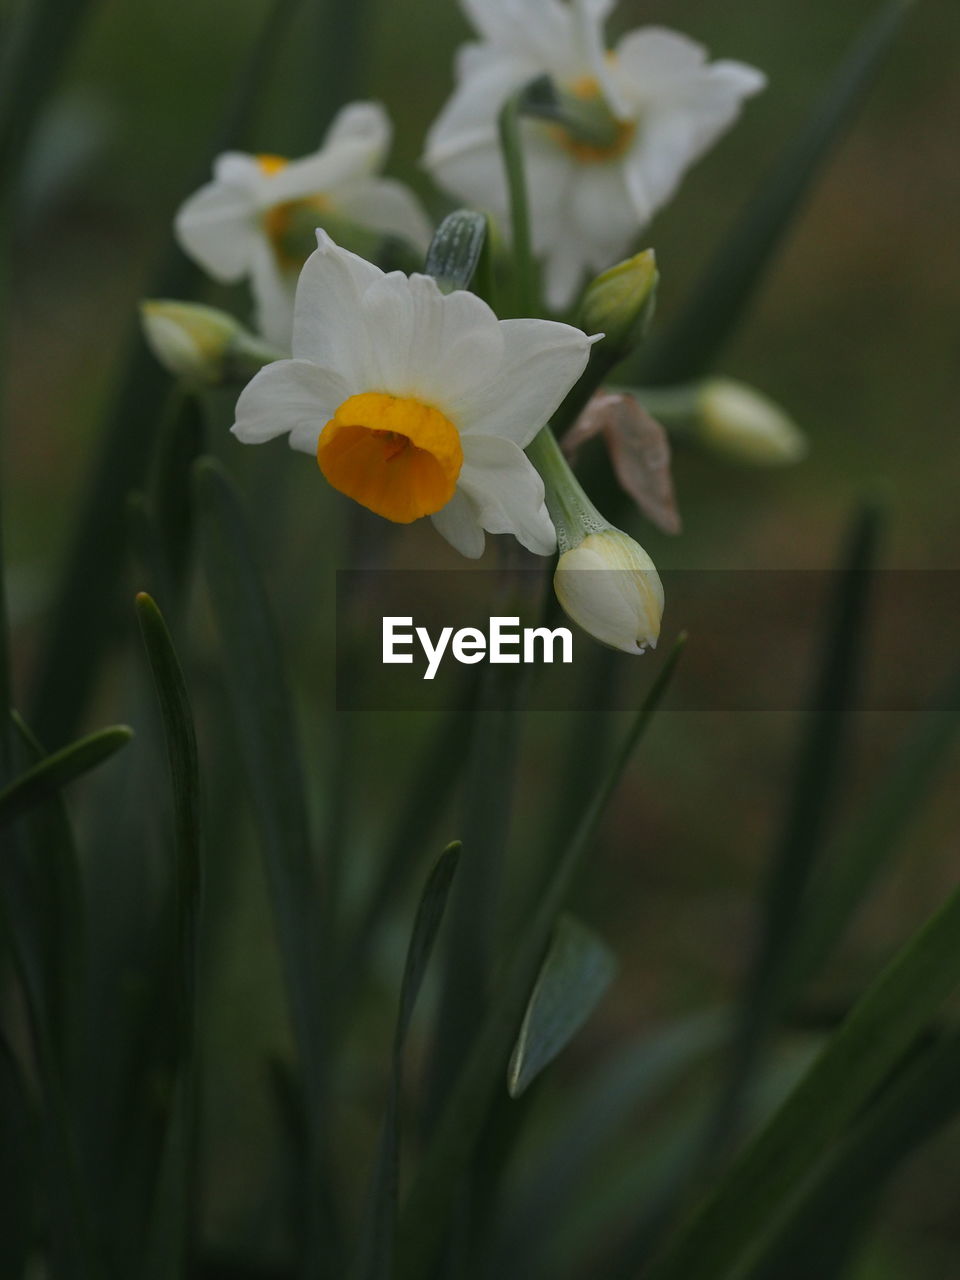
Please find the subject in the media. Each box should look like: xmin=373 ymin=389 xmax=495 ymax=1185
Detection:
xmin=173 ymin=180 xmax=260 ymax=283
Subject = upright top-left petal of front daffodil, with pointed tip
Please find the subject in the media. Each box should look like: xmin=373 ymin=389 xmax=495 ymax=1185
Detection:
xmin=293 ymin=230 xmax=383 ymax=381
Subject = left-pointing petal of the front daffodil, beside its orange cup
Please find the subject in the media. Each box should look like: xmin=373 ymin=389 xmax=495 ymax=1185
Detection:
xmin=230 ymin=360 xmax=348 ymax=453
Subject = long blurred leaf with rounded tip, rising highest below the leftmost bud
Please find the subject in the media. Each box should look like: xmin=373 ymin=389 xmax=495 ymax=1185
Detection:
xmin=195 ymin=458 xmax=334 ymax=1269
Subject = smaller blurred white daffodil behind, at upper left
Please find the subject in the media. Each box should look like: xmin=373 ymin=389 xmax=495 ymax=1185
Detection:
xmin=174 ymin=102 xmax=430 ymax=351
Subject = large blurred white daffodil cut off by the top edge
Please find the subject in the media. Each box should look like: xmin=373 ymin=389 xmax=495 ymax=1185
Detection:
xmin=424 ymin=0 xmax=765 ymax=307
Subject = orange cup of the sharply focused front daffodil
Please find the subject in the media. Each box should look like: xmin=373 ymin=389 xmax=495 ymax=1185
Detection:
xmin=316 ymin=392 xmax=463 ymax=525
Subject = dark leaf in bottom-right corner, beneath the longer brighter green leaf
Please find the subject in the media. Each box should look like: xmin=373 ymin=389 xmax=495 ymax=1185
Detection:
xmin=748 ymin=1030 xmax=960 ymax=1280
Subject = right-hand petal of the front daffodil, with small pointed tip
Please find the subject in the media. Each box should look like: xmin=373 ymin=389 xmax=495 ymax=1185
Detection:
xmin=451 ymin=320 xmax=590 ymax=445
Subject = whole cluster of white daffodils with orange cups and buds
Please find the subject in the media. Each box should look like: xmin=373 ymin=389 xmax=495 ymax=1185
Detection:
xmin=143 ymin=0 xmax=801 ymax=653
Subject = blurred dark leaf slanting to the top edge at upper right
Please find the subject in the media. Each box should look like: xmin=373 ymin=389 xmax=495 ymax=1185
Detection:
xmin=635 ymin=0 xmax=910 ymax=387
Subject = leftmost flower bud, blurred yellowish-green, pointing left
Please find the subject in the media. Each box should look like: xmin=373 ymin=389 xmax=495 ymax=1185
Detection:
xmin=140 ymin=300 xmax=283 ymax=387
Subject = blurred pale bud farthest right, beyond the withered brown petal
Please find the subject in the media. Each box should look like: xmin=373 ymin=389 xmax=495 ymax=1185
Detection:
xmin=696 ymin=378 xmax=806 ymax=466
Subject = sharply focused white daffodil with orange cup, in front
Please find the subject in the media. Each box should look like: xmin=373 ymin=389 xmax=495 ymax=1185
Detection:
xmin=233 ymin=230 xmax=591 ymax=558
